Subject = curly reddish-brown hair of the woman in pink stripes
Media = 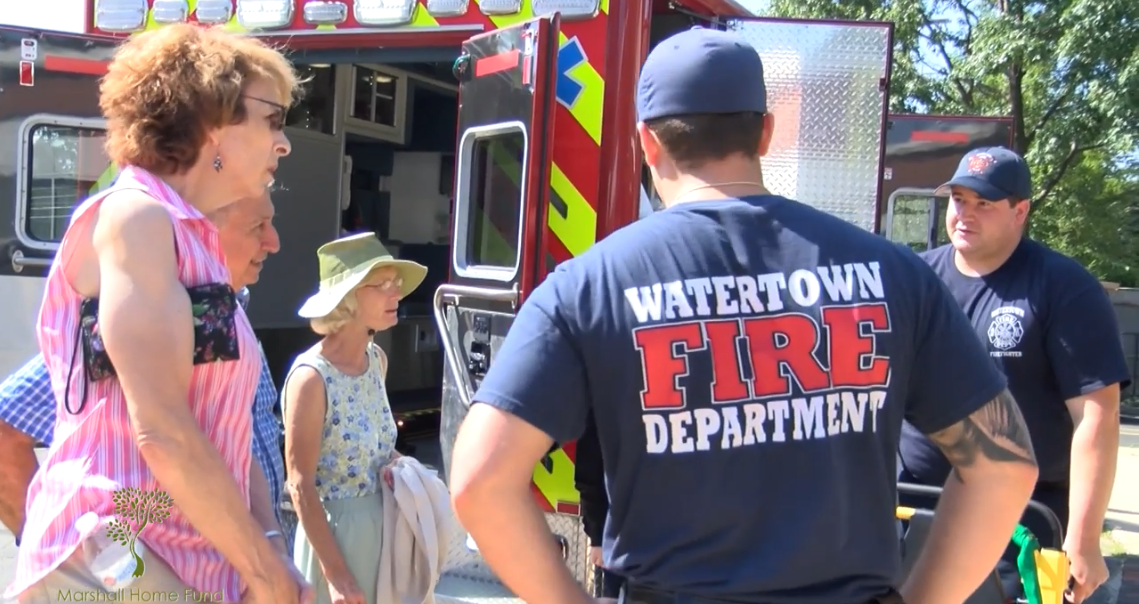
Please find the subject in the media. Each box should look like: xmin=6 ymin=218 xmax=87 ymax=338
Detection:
xmin=99 ymin=24 xmax=300 ymax=176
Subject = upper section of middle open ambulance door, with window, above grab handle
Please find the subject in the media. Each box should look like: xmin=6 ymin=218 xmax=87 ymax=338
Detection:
xmin=450 ymin=18 xmax=558 ymax=305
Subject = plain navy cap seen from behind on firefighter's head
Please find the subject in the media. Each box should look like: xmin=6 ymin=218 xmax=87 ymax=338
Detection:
xmin=637 ymin=27 xmax=768 ymax=122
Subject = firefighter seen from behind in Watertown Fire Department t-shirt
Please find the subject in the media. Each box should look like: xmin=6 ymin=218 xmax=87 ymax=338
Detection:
xmin=450 ymin=28 xmax=1036 ymax=604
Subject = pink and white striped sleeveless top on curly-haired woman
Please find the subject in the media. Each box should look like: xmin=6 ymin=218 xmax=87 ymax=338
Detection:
xmin=5 ymin=168 xmax=261 ymax=602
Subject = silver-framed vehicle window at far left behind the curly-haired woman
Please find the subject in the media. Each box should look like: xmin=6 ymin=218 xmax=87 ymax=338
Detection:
xmin=17 ymin=117 xmax=116 ymax=250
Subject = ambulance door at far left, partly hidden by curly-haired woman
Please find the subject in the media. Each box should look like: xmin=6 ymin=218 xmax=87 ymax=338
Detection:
xmin=0 ymin=29 xmax=116 ymax=376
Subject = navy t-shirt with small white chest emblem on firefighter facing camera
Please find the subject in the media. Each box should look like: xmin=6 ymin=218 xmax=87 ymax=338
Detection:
xmin=899 ymin=239 xmax=1131 ymax=487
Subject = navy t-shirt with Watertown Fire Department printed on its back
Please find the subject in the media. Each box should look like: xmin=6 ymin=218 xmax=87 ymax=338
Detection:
xmin=475 ymin=196 xmax=1005 ymax=604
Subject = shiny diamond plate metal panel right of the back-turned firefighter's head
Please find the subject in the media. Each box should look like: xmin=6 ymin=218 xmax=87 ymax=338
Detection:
xmin=729 ymin=21 xmax=892 ymax=230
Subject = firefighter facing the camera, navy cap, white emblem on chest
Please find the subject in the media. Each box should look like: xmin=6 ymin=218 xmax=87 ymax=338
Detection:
xmin=899 ymin=147 xmax=1131 ymax=603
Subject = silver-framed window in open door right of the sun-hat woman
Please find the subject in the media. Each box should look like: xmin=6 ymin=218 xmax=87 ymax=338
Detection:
xmin=453 ymin=122 xmax=527 ymax=281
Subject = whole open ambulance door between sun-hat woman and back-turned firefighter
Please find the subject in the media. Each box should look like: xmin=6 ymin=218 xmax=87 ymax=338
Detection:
xmin=434 ymin=15 xmax=569 ymax=602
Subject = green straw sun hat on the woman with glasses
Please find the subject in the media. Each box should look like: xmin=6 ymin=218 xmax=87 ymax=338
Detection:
xmin=297 ymin=232 xmax=427 ymax=319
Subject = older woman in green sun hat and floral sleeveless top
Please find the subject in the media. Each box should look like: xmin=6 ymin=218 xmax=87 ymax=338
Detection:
xmin=281 ymin=232 xmax=427 ymax=604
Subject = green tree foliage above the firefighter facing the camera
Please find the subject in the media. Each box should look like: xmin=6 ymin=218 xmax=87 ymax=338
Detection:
xmin=765 ymin=0 xmax=1139 ymax=285
